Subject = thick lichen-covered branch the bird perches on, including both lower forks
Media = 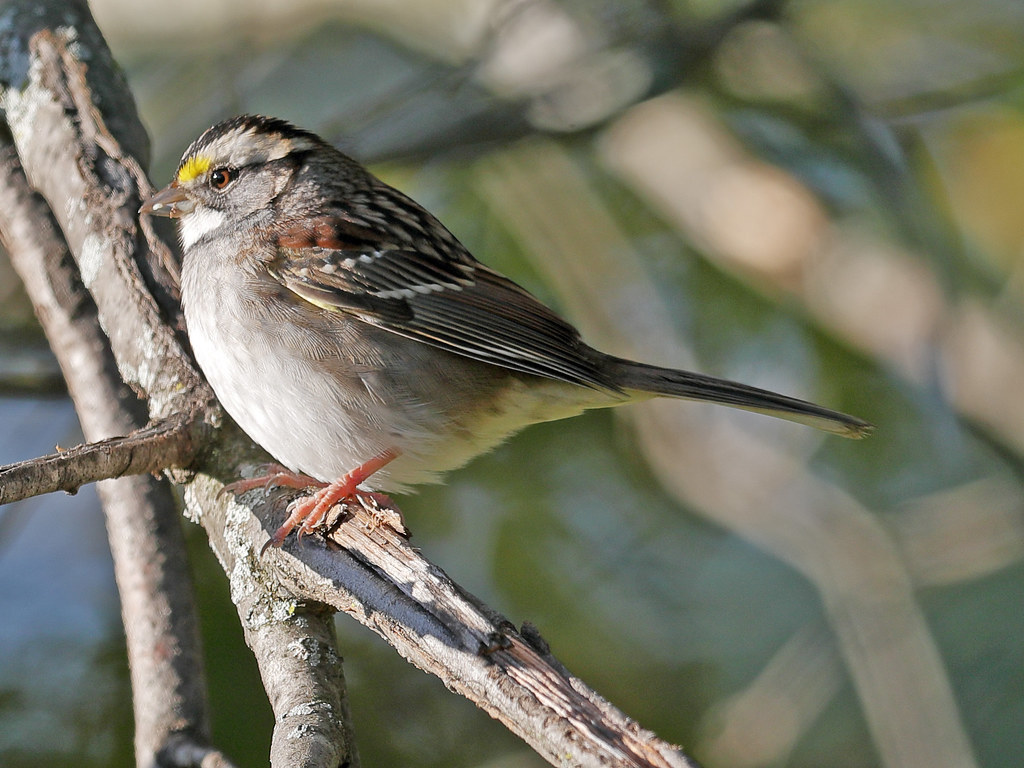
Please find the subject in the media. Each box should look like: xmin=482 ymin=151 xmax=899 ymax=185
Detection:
xmin=0 ymin=2 xmax=692 ymax=768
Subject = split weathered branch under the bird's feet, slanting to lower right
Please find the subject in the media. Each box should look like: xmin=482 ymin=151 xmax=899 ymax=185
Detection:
xmin=192 ymin=477 xmax=694 ymax=768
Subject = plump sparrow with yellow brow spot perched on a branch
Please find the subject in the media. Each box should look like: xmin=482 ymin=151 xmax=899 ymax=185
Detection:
xmin=140 ymin=116 xmax=870 ymax=545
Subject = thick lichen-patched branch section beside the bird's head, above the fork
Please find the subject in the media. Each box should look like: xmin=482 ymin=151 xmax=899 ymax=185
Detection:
xmin=0 ymin=2 xmax=203 ymax=419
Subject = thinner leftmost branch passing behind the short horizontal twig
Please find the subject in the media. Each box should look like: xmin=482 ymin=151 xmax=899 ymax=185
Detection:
xmin=0 ymin=115 xmax=230 ymax=768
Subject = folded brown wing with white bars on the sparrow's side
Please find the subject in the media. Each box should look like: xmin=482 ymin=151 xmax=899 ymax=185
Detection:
xmin=272 ymin=219 xmax=616 ymax=390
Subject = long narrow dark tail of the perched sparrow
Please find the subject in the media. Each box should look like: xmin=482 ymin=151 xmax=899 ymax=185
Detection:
xmin=608 ymin=358 xmax=874 ymax=438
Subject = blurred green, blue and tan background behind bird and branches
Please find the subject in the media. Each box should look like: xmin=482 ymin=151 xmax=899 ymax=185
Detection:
xmin=0 ymin=0 xmax=1024 ymax=768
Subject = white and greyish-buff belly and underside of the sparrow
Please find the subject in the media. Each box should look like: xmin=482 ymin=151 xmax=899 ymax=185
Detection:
xmin=183 ymin=273 xmax=613 ymax=490
